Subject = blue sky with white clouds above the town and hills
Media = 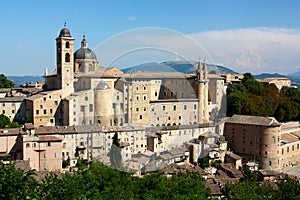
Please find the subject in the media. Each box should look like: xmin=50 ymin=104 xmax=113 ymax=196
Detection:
xmin=0 ymin=0 xmax=300 ymax=76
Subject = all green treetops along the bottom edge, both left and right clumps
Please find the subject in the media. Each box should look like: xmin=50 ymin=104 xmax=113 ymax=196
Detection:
xmin=0 ymin=162 xmax=300 ymax=199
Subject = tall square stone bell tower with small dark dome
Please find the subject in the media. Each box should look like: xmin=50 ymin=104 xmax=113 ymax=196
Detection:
xmin=56 ymin=23 xmax=74 ymax=97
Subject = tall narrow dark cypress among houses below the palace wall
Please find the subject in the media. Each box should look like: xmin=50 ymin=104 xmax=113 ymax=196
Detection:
xmin=109 ymin=132 xmax=122 ymax=169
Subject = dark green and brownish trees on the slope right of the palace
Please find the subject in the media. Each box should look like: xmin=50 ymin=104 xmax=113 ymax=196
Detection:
xmin=227 ymin=73 xmax=300 ymax=122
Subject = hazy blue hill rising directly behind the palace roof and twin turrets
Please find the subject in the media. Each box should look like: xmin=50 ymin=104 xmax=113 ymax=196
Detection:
xmin=122 ymin=61 xmax=237 ymax=74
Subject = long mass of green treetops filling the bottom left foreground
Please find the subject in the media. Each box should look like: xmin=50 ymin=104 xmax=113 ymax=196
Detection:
xmin=0 ymin=161 xmax=209 ymax=199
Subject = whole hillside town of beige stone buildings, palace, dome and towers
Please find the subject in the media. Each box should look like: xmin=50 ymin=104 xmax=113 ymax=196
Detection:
xmin=0 ymin=26 xmax=300 ymax=195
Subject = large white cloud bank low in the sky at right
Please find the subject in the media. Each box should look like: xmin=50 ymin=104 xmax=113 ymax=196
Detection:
xmin=192 ymin=28 xmax=300 ymax=74
